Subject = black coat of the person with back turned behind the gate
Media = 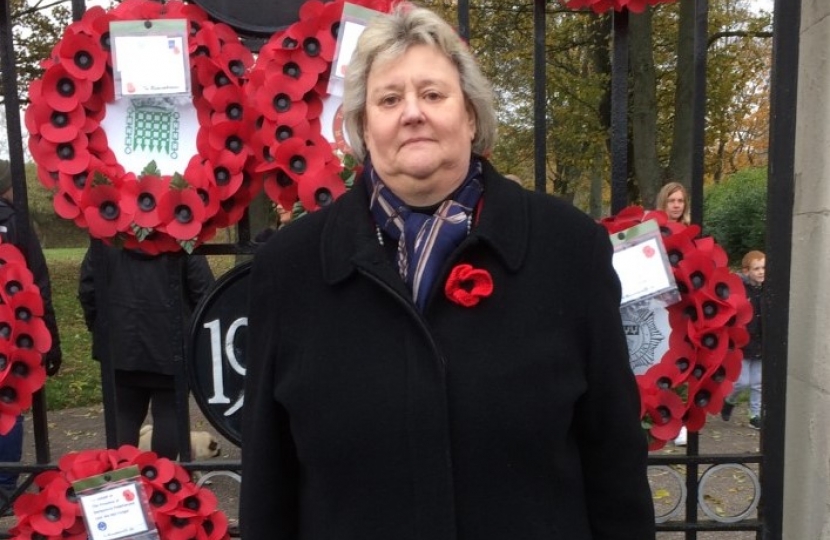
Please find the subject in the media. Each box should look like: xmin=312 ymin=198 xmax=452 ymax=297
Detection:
xmin=78 ymin=244 xmax=214 ymax=375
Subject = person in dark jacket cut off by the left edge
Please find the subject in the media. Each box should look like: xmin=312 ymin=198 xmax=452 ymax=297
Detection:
xmin=0 ymin=159 xmax=63 ymax=491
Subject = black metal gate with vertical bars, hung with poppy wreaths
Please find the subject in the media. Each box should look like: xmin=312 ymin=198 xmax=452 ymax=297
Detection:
xmin=0 ymin=0 xmax=801 ymax=540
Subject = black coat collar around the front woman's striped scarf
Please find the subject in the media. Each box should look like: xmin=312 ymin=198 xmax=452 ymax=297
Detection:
xmin=320 ymin=160 xmax=530 ymax=291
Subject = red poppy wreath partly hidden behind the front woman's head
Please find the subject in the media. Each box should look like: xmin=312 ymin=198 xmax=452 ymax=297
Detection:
xmin=247 ymin=0 xmax=392 ymax=215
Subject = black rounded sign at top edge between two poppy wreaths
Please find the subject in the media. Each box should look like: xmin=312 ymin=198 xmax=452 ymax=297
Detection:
xmin=194 ymin=0 xmax=304 ymax=34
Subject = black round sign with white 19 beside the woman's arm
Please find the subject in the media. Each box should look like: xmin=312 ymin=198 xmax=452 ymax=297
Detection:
xmin=187 ymin=261 xmax=252 ymax=446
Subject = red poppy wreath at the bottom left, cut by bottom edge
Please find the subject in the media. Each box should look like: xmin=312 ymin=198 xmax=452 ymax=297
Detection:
xmin=10 ymin=445 xmax=230 ymax=540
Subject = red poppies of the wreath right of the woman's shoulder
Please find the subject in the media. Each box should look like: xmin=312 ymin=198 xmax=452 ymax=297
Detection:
xmin=601 ymin=206 xmax=752 ymax=450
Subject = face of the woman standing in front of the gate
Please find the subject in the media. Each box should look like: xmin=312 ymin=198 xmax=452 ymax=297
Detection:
xmin=363 ymin=45 xmax=475 ymax=206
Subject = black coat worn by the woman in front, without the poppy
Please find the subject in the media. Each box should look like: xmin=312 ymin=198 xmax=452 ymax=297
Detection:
xmin=240 ymin=165 xmax=654 ymax=540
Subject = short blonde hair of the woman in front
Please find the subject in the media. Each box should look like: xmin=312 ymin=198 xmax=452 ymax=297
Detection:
xmin=343 ymin=2 xmax=497 ymax=161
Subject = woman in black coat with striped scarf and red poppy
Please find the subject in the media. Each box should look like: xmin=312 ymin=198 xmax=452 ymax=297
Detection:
xmin=240 ymin=5 xmax=654 ymax=540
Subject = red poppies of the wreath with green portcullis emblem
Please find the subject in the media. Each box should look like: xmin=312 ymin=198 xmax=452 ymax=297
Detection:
xmin=25 ymin=0 xmax=262 ymax=253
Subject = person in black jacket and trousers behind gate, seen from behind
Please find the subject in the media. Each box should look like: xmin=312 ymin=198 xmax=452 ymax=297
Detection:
xmin=78 ymin=243 xmax=214 ymax=459
